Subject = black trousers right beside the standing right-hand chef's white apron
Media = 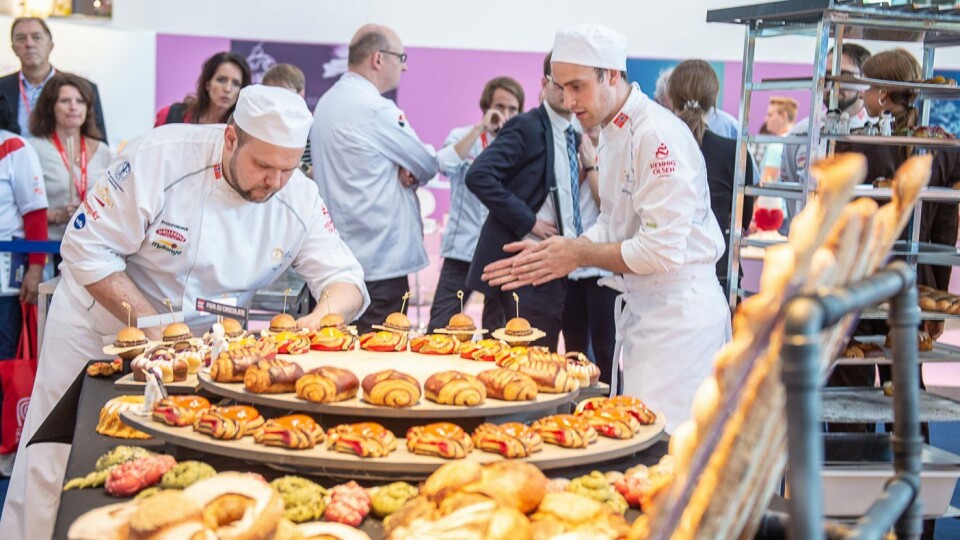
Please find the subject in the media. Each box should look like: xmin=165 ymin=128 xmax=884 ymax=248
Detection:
xmin=563 ymin=277 xmax=619 ymax=384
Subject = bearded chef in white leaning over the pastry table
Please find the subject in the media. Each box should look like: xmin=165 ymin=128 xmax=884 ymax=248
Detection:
xmin=0 ymin=85 xmax=369 ymax=539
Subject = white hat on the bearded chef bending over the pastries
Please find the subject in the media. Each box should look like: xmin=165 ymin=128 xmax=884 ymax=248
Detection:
xmin=233 ymin=84 xmax=313 ymax=148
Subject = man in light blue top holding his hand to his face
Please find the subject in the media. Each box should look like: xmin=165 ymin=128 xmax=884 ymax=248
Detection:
xmin=428 ymin=77 xmax=524 ymax=331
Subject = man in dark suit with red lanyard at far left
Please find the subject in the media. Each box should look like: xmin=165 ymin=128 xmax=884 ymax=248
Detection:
xmin=0 ymin=17 xmax=107 ymax=141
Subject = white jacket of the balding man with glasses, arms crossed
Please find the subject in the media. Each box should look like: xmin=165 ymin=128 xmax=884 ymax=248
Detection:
xmin=311 ymin=71 xmax=456 ymax=281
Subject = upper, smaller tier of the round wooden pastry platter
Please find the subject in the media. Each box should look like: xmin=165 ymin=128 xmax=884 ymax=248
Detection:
xmin=197 ymin=351 xmax=579 ymax=419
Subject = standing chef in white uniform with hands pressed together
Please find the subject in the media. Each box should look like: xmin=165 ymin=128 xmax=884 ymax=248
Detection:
xmin=484 ymin=25 xmax=730 ymax=432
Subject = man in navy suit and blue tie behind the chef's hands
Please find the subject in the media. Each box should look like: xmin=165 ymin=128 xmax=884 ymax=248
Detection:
xmin=466 ymin=55 xmax=580 ymax=350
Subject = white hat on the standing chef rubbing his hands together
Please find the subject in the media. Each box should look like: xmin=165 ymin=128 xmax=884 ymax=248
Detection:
xmin=551 ymin=24 xmax=627 ymax=71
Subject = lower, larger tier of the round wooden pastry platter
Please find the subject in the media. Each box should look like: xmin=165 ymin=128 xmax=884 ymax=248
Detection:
xmin=120 ymin=411 xmax=666 ymax=477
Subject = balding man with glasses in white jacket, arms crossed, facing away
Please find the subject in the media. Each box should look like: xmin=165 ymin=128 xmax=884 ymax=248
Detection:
xmin=311 ymin=24 xmax=456 ymax=332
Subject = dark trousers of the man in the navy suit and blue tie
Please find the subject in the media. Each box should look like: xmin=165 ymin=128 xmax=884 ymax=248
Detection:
xmin=499 ymin=278 xmax=567 ymax=351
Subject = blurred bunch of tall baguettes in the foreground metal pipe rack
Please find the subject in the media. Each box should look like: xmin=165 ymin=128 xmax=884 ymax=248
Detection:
xmin=629 ymin=154 xmax=932 ymax=540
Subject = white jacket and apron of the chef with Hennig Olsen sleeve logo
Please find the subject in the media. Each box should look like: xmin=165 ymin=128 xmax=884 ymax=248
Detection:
xmin=584 ymin=84 xmax=730 ymax=432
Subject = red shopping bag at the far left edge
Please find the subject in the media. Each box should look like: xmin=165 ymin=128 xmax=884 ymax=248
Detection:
xmin=0 ymin=304 xmax=37 ymax=454
